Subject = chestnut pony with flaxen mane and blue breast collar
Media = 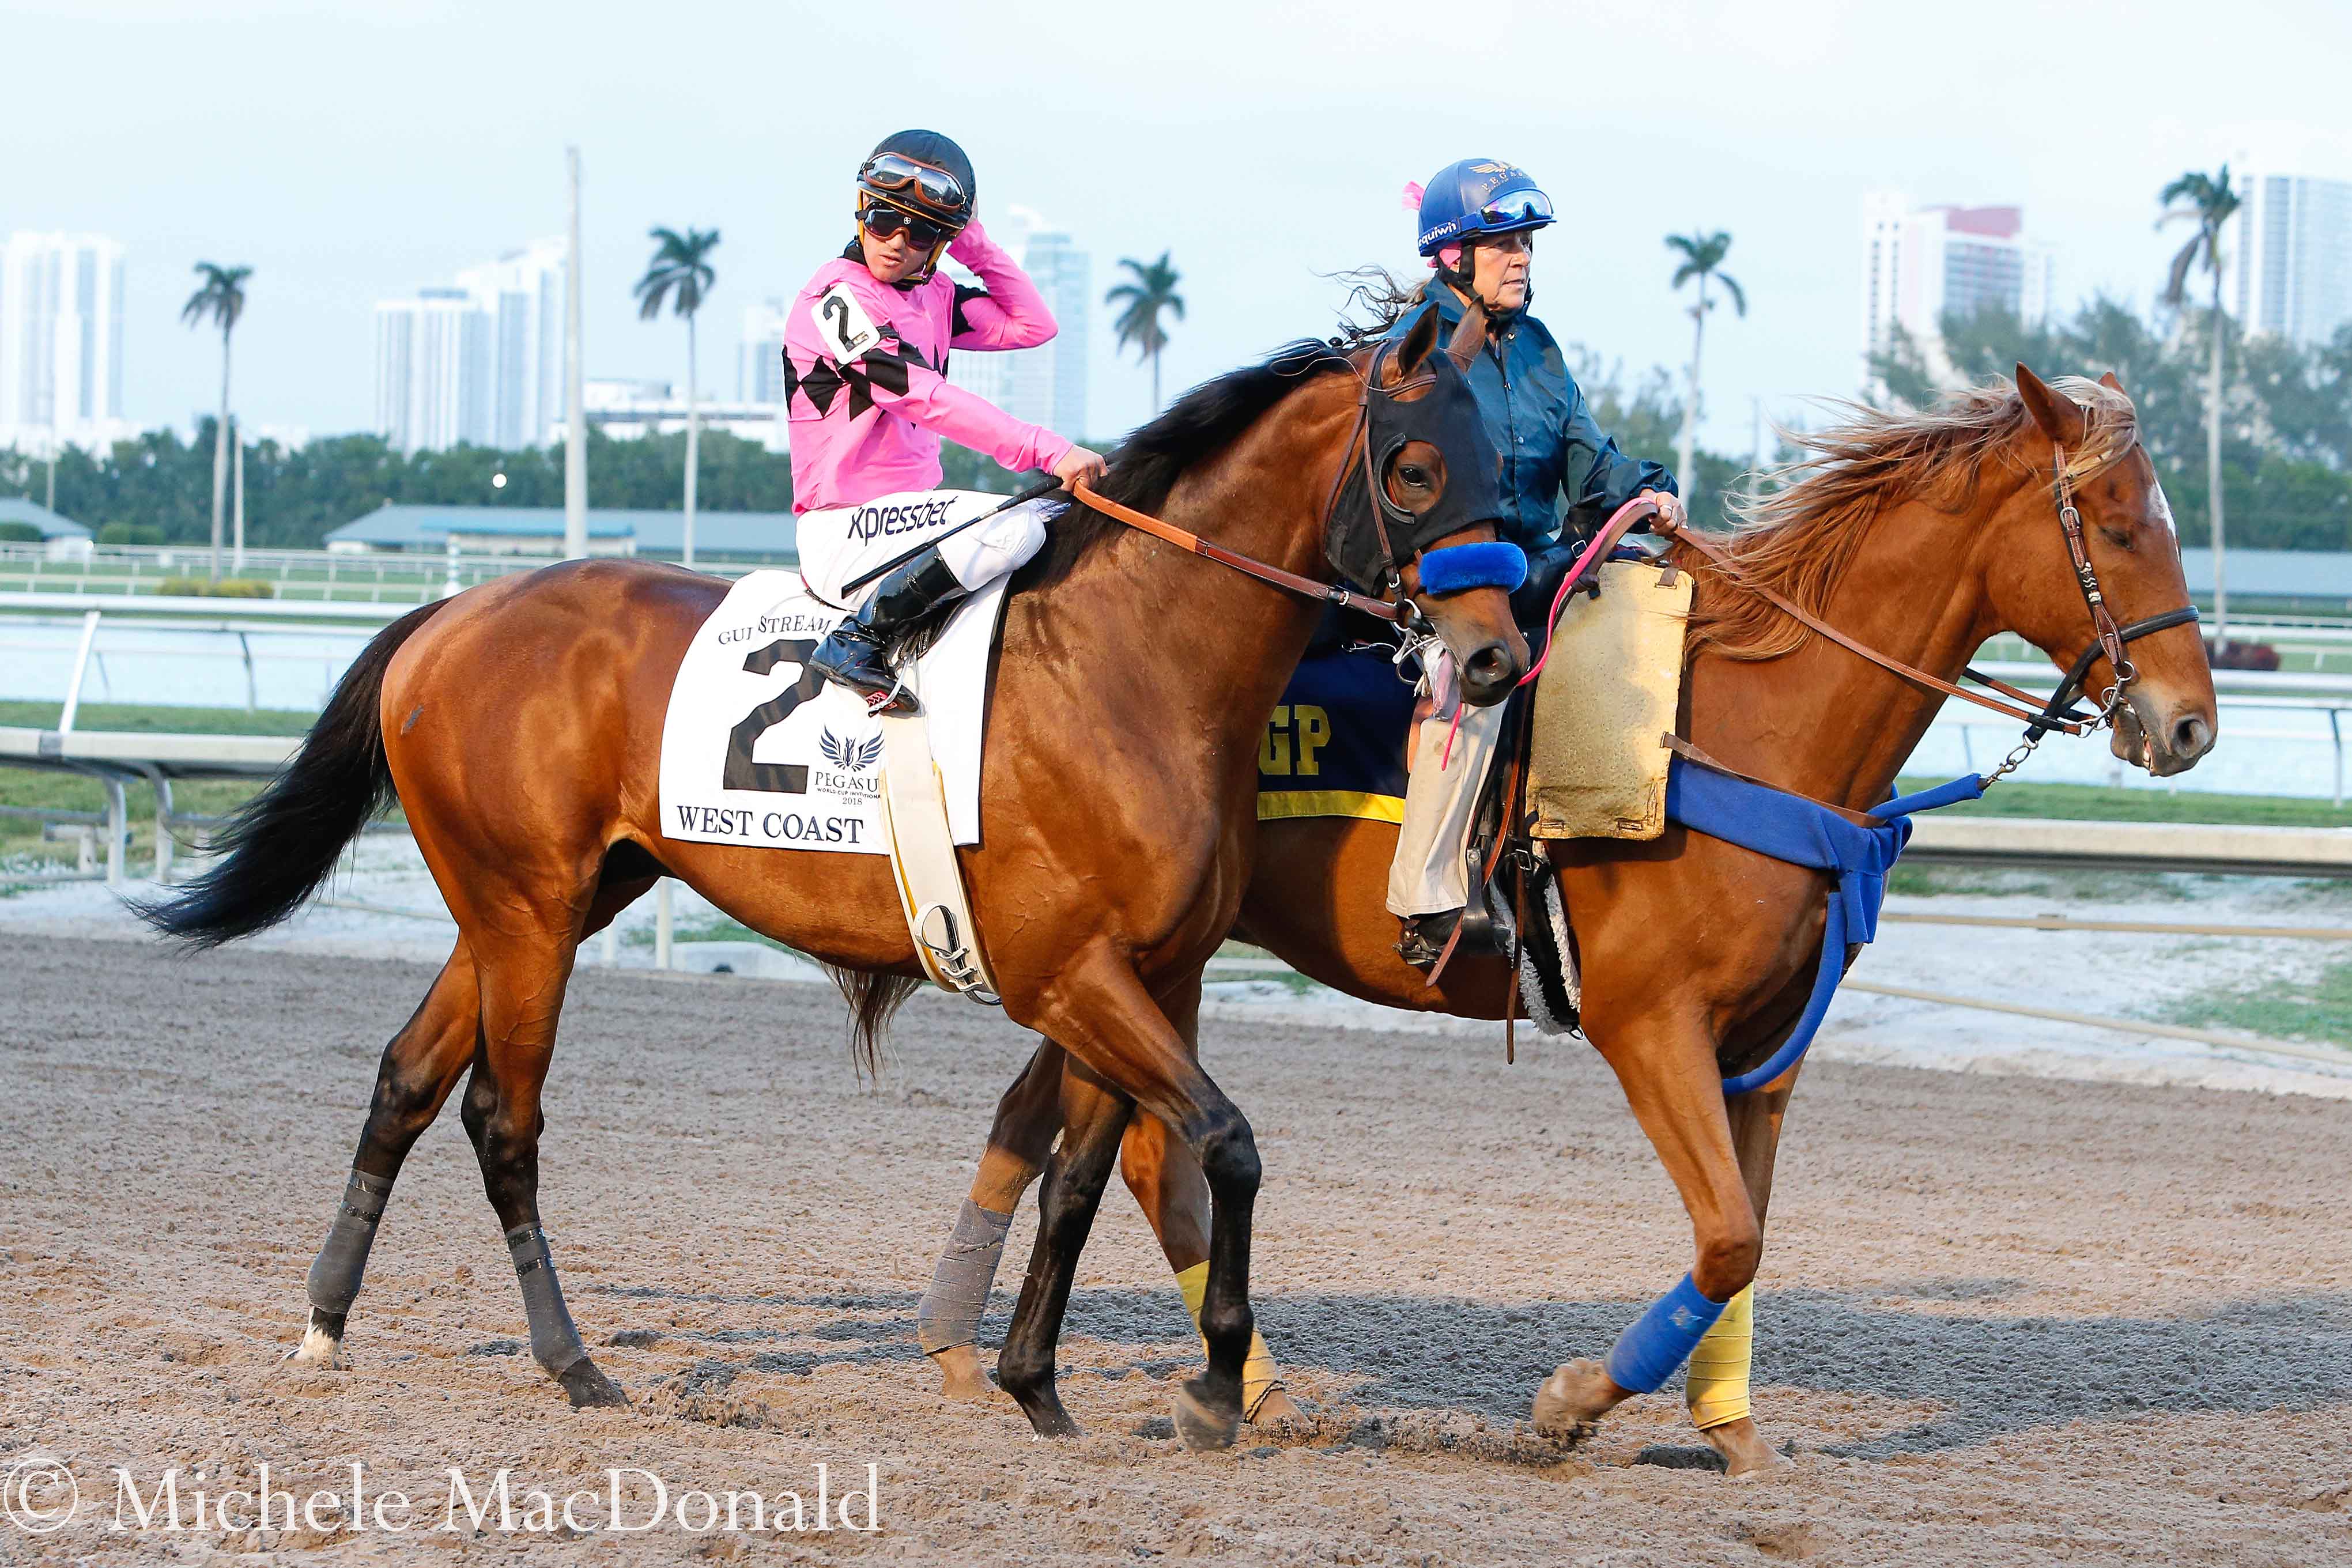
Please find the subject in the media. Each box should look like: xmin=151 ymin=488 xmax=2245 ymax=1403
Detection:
xmin=912 ymin=364 xmax=2215 ymax=1474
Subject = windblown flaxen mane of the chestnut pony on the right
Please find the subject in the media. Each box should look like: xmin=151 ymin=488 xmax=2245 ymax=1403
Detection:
xmin=1682 ymin=376 xmax=2138 ymax=660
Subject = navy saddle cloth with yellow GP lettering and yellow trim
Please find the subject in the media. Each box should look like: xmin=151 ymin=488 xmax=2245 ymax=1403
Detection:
xmin=1258 ymin=647 xmax=1414 ymax=823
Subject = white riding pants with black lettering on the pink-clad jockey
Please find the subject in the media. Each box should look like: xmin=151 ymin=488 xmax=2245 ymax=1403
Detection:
xmin=797 ymin=489 xmax=1066 ymax=607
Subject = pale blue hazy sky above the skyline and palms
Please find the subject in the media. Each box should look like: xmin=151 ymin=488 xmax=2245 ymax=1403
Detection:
xmin=0 ymin=0 xmax=2352 ymax=451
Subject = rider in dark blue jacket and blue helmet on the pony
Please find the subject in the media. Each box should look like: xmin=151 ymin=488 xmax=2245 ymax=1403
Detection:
xmin=1388 ymin=157 xmax=1679 ymax=969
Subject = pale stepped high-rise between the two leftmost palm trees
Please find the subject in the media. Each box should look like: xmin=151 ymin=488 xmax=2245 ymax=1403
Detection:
xmin=376 ymin=240 xmax=564 ymax=451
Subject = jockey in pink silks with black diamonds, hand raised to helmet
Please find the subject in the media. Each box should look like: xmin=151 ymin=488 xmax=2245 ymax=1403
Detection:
xmin=783 ymin=131 xmax=1103 ymax=712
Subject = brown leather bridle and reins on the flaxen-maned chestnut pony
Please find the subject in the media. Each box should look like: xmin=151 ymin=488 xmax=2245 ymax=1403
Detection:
xmin=1646 ymin=447 xmax=2197 ymax=785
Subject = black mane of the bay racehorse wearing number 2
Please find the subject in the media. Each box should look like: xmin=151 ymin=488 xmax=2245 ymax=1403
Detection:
xmin=1016 ymin=338 xmax=1350 ymax=588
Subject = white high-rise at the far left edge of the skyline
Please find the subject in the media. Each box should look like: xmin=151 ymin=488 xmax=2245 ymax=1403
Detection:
xmin=0 ymin=233 xmax=129 ymax=451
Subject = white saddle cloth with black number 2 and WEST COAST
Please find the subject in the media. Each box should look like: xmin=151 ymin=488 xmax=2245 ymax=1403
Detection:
xmin=661 ymin=569 xmax=1005 ymax=856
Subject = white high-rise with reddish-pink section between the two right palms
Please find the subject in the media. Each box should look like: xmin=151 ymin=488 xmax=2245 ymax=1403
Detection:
xmin=1863 ymin=190 xmax=2058 ymax=390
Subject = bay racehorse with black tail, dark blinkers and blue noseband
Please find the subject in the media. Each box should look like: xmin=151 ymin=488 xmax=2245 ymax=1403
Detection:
xmin=148 ymin=318 xmax=1527 ymax=1446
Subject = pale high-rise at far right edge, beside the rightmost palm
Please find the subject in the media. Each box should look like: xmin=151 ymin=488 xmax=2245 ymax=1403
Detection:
xmin=2223 ymin=169 xmax=2352 ymax=348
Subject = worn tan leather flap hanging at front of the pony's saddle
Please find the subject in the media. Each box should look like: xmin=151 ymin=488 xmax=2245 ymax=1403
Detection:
xmin=1527 ymin=562 xmax=1691 ymax=839
